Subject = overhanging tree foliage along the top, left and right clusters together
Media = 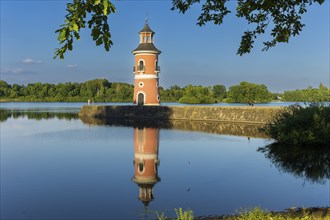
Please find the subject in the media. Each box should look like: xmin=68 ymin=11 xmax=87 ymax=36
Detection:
xmin=54 ymin=0 xmax=325 ymax=59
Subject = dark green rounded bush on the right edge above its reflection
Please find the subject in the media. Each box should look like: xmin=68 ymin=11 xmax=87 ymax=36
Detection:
xmin=261 ymin=104 xmax=330 ymax=146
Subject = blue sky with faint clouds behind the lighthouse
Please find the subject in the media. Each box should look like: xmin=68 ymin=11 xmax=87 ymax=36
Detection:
xmin=0 ymin=0 xmax=330 ymax=92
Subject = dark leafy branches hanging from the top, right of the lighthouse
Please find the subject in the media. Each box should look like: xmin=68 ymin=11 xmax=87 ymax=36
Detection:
xmin=171 ymin=0 xmax=324 ymax=56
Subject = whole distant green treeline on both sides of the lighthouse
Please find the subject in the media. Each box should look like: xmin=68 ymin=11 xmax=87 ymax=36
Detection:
xmin=0 ymin=79 xmax=330 ymax=104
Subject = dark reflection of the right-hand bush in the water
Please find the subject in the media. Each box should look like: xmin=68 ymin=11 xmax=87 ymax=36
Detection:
xmin=258 ymin=143 xmax=330 ymax=183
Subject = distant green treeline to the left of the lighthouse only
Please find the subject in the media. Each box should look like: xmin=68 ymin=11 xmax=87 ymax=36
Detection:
xmin=0 ymin=79 xmax=133 ymax=102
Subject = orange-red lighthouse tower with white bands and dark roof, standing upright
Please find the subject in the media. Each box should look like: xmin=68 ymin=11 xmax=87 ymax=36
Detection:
xmin=132 ymin=19 xmax=161 ymax=105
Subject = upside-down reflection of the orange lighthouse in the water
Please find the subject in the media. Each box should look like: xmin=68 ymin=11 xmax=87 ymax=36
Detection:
xmin=132 ymin=127 xmax=160 ymax=208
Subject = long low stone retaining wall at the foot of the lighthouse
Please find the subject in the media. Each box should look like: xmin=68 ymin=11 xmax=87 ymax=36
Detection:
xmin=79 ymin=105 xmax=283 ymax=124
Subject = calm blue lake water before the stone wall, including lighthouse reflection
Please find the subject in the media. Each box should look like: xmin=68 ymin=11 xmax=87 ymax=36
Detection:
xmin=0 ymin=103 xmax=330 ymax=219
